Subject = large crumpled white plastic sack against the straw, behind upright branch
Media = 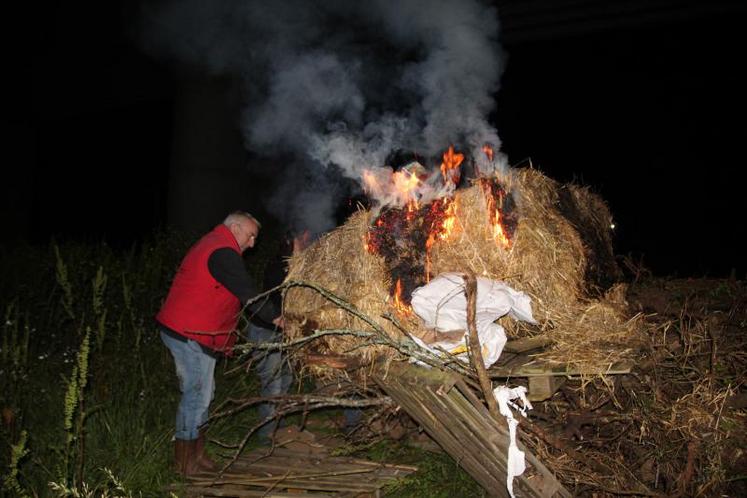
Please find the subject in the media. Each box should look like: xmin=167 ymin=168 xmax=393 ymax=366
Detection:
xmin=411 ymin=273 xmax=537 ymax=368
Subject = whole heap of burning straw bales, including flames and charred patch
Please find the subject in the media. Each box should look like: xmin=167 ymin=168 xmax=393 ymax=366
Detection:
xmin=285 ymin=162 xmax=638 ymax=370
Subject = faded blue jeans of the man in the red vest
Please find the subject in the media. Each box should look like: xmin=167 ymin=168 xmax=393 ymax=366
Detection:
xmin=161 ymin=332 xmax=215 ymax=440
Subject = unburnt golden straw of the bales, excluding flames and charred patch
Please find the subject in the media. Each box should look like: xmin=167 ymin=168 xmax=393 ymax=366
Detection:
xmin=285 ymin=168 xmax=639 ymax=376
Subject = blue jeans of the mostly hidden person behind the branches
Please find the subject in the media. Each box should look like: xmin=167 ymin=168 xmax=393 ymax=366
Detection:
xmin=247 ymin=323 xmax=293 ymax=437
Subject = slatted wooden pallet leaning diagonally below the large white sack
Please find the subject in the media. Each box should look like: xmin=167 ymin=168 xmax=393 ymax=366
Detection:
xmin=373 ymin=362 xmax=571 ymax=498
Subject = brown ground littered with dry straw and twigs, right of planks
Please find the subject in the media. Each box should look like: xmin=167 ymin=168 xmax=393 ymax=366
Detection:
xmin=516 ymin=278 xmax=747 ymax=496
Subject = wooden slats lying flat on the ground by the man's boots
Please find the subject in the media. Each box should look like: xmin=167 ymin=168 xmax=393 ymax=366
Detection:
xmin=179 ymin=447 xmax=417 ymax=498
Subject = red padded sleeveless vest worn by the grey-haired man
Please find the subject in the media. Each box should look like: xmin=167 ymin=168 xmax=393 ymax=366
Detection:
xmin=156 ymin=225 xmax=241 ymax=353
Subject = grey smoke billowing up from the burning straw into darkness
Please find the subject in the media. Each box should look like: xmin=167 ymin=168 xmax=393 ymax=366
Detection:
xmin=143 ymin=0 xmax=505 ymax=233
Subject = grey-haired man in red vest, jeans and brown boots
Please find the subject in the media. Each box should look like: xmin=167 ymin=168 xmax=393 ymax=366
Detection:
xmin=156 ymin=211 xmax=282 ymax=476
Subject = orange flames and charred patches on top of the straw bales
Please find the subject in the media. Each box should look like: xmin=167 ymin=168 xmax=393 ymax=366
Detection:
xmin=362 ymin=145 xmax=518 ymax=314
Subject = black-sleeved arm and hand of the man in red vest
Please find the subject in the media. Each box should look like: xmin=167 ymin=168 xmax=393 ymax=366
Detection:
xmin=208 ymin=247 xmax=280 ymax=328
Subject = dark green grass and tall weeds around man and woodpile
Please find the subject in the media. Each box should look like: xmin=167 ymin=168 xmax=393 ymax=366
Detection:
xmin=0 ymin=233 xmax=481 ymax=497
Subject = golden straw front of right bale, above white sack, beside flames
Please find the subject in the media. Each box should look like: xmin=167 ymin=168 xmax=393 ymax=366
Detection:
xmin=431 ymin=169 xmax=586 ymax=321
